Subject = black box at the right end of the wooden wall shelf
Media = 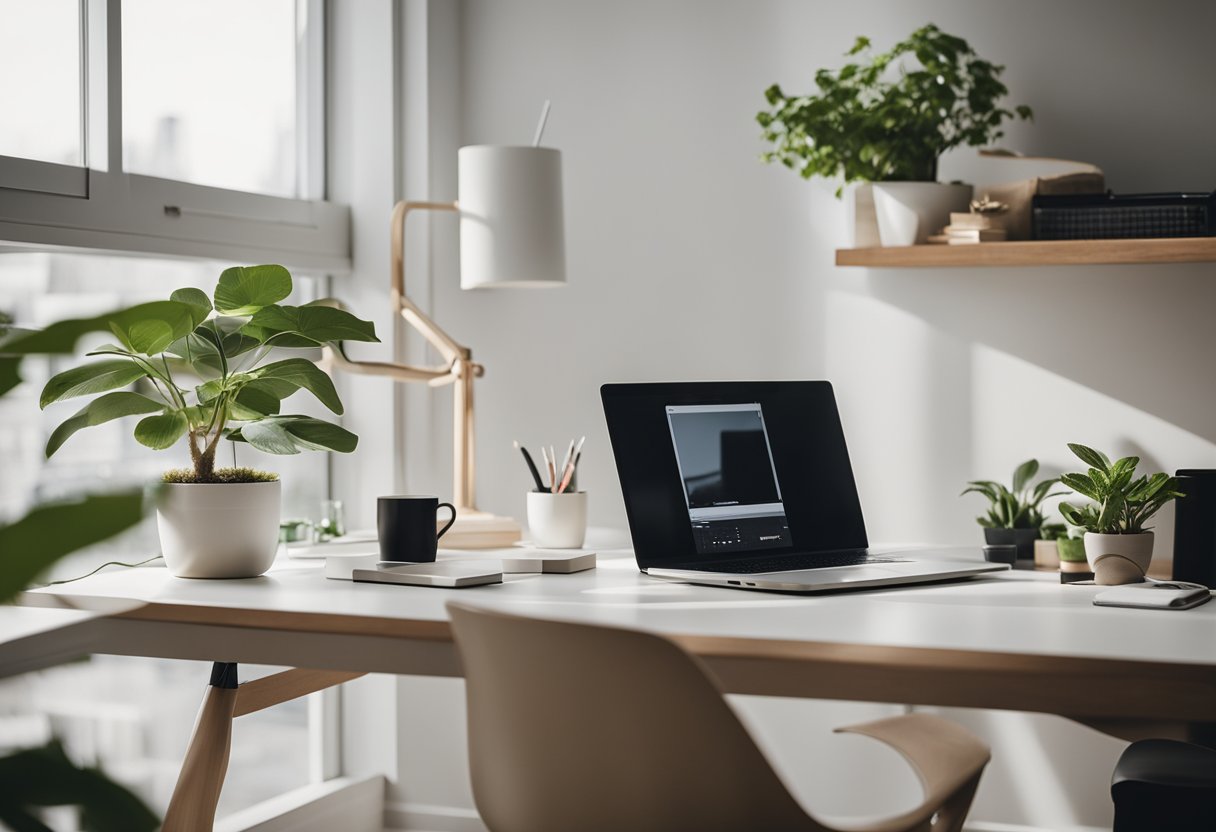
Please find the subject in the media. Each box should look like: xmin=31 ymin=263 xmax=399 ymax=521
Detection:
xmin=1031 ymin=192 xmax=1216 ymax=240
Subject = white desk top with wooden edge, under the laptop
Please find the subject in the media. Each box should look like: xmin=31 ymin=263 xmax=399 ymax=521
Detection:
xmin=24 ymin=551 xmax=1216 ymax=736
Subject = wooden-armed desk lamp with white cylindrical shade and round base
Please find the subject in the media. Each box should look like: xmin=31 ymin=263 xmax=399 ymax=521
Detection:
xmin=326 ymin=145 xmax=565 ymax=549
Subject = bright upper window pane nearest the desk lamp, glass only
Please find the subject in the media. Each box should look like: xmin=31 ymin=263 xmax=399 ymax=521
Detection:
xmin=123 ymin=0 xmax=300 ymax=197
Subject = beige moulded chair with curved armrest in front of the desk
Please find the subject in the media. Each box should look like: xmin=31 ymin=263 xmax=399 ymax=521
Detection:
xmin=447 ymin=603 xmax=989 ymax=832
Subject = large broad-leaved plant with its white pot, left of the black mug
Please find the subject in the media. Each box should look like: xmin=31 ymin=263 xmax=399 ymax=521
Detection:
xmin=34 ymin=265 xmax=377 ymax=578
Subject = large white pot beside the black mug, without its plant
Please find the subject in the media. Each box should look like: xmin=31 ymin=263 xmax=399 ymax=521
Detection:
xmin=156 ymin=480 xmax=282 ymax=578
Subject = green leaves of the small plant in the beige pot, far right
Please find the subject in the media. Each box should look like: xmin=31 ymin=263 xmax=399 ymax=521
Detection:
xmin=1060 ymin=443 xmax=1186 ymax=534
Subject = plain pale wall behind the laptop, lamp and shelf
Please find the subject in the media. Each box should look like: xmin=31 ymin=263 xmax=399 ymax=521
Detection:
xmin=356 ymin=0 xmax=1216 ymax=830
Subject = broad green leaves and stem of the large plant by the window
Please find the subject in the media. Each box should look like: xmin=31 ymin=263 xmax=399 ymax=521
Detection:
xmin=8 ymin=265 xmax=378 ymax=483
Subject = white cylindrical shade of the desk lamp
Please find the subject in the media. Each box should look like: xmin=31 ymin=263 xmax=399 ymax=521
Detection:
xmin=457 ymin=145 xmax=565 ymax=289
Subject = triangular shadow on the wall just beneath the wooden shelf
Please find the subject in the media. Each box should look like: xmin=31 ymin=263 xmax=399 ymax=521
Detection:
xmin=866 ymin=264 xmax=1216 ymax=447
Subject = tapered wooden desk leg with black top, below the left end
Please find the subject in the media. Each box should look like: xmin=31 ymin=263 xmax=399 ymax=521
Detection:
xmin=162 ymin=662 xmax=237 ymax=832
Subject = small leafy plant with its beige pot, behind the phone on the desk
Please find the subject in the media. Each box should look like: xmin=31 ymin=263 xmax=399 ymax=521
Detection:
xmin=1060 ymin=443 xmax=1184 ymax=585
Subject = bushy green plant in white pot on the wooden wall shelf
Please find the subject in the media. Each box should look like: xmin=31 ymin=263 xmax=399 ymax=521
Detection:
xmin=756 ymin=24 xmax=1031 ymax=246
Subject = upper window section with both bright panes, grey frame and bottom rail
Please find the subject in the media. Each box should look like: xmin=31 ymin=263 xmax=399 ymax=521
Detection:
xmin=0 ymin=0 xmax=350 ymax=272
